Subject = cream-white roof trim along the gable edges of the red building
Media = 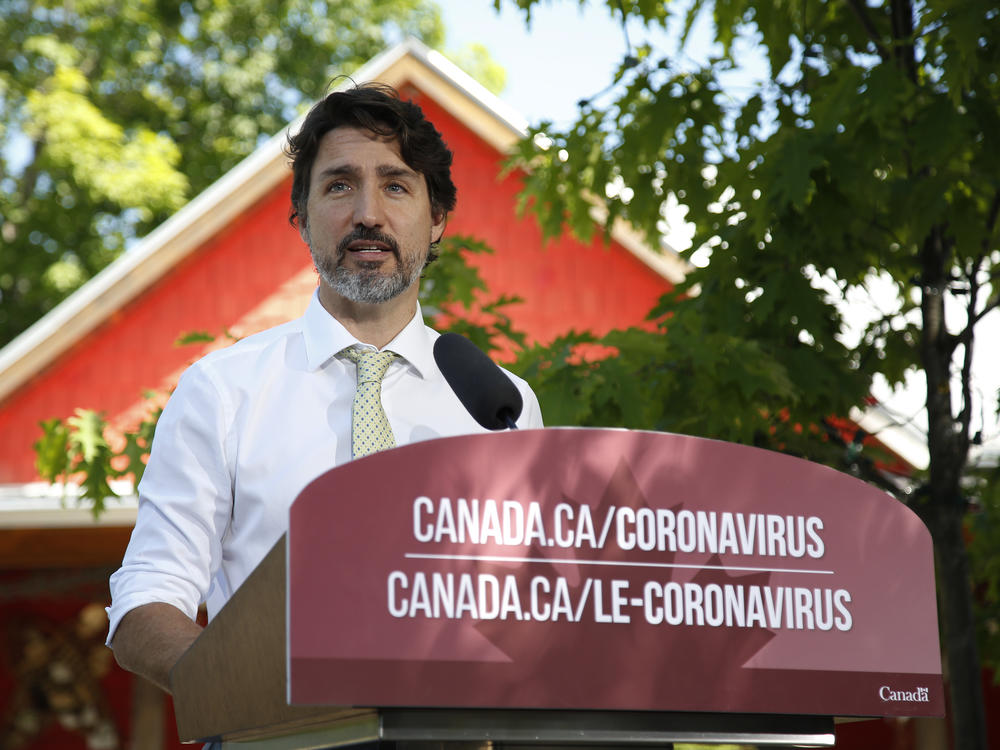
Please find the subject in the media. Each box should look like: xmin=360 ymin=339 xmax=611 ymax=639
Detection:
xmin=0 ymin=38 xmax=683 ymax=408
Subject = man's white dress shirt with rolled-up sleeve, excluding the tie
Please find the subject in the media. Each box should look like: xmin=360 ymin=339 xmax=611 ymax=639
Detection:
xmin=108 ymin=294 xmax=542 ymax=644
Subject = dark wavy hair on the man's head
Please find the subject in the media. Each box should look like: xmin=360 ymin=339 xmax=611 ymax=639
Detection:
xmin=285 ymin=83 xmax=457 ymax=244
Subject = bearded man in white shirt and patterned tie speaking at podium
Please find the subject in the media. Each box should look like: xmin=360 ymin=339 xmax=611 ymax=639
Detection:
xmin=108 ymin=85 xmax=542 ymax=691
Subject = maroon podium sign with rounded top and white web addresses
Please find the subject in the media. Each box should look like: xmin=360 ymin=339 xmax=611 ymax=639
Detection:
xmin=288 ymin=428 xmax=944 ymax=716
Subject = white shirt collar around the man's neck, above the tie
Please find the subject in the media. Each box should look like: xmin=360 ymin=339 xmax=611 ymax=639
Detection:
xmin=302 ymin=291 xmax=435 ymax=378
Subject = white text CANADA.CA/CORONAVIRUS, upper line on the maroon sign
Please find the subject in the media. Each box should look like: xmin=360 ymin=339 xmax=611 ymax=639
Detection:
xmin=413 ymin=496 xmax=825 ymax=559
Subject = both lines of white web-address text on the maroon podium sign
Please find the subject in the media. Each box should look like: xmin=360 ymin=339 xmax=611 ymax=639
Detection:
xmin=386 ymin=496 xmax=853 ymax=631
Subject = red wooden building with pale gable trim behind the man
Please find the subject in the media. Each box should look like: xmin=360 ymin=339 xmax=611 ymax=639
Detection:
xmin=0 ymin=41 xmax=964 ymax=750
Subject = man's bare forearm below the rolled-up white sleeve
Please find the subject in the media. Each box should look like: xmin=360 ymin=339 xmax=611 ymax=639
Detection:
xmin=111 ymin=603 xmax=202 ymax=693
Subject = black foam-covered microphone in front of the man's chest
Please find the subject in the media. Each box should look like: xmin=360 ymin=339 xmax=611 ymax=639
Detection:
xmin=434 ymin=333 xmax=524 ymax=430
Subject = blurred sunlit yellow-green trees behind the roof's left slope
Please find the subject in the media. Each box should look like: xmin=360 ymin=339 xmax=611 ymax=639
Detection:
xmin=0 ymin=0 xmax=446 ymax=346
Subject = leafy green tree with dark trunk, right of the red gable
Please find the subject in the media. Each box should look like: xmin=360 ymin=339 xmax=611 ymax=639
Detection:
xmin=495 ymin=5 xmax=1000 ymax=748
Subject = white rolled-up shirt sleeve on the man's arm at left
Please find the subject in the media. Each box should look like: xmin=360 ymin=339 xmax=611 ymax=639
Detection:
xmin=107 ymin=363 xmax=233 ymax=645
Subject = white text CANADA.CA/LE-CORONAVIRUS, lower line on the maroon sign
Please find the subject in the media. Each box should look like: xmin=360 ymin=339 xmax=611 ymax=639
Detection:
xmin=386 ymin=570 xmax=853 ymax=631
